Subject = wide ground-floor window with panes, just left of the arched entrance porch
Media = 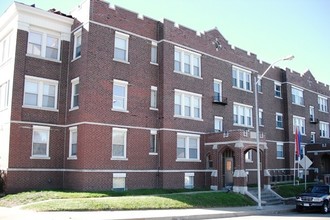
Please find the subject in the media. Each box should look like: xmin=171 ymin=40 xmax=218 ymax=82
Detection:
xmin=176 ymin=133 xmax=200 ymax=161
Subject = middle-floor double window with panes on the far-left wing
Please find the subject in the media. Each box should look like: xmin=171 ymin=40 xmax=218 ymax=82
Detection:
xmin=24 ymin=76 xmax=58 ymax=110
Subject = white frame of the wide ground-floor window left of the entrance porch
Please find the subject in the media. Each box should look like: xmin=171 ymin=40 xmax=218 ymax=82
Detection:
xmin=176 ymin=133 xmax=201 ymax=162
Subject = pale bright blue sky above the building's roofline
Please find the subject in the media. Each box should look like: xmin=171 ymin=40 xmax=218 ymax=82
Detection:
xmin=0 ymin=0 xmax=330 ymax=85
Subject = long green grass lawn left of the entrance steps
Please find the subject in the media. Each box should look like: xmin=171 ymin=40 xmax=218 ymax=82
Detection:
xmin=0 ymin=190 xmax=255 ymax=211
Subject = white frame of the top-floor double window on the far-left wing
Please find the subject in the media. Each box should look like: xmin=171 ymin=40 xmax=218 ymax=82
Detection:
xmin=27 ymin=28 xmax=61 ymax=61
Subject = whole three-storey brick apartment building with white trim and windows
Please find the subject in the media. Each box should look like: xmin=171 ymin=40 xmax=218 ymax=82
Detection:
xmin=0 ymin=0 xmax=330 ymax=193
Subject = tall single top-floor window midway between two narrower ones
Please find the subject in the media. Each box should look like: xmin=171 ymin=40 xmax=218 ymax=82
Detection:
xmin=114 ymin=31 xmax=129 ymax=62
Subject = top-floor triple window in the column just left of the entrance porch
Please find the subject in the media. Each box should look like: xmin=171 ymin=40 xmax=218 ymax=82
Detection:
xmin=174 ymin=47 xmax=201 ymax=77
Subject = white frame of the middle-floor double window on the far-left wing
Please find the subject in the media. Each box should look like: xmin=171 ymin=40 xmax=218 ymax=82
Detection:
xmin=23 ymin=75 xmax=58 ymax=111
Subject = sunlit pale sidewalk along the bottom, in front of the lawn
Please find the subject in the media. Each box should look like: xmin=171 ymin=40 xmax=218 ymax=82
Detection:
xmin=0 ymin=205 xmax=295 ymax=220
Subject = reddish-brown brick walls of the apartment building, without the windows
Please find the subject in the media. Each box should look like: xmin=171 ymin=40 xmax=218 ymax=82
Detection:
xmin=0 ymin=0 xmax=330 ymax=192
